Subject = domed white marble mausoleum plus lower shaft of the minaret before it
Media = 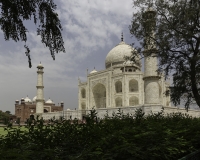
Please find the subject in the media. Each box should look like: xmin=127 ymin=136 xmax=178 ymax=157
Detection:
xmin=78 ymin=35 xmax=170 ymax=110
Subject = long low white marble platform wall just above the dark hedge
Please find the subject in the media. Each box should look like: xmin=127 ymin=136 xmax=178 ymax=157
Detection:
xmin=38 ymin=105 xmax=200 ymax=120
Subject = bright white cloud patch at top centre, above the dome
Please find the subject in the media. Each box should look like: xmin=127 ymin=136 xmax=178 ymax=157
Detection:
xmin=59 ymin=0 xmax=132 ymax=59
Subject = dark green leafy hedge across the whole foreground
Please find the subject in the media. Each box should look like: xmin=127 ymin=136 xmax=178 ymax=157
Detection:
xmin=0 ymin=109 xmax=200 ymax=160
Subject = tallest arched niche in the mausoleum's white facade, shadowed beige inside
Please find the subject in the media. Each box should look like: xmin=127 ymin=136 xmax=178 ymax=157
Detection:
xmin=92 ymin=83 xmax=106 ymax=108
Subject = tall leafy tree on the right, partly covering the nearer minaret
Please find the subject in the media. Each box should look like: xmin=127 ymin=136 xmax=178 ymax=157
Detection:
xmin=129 ymin=0 xmax=200 ymax=109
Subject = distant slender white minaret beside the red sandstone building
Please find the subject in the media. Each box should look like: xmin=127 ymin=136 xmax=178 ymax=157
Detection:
xmin=36 ymin=62 xmax=44 ymax=114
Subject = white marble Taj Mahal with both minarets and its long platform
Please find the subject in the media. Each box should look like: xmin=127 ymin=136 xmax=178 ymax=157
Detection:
xmin=15 ymin=9 xmax=200 ymax=120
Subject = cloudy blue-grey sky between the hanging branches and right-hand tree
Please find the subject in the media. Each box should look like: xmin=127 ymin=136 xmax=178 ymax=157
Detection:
xmin=0 ymin=0 xmax=139 ymax=114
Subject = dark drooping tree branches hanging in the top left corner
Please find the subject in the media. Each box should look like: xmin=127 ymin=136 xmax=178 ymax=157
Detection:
xmin=0 ymin=0 xmax=65 ymax=68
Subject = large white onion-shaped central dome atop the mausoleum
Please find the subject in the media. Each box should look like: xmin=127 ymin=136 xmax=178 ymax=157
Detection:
xmin=105 ymin=41 xmax=140 ymax=69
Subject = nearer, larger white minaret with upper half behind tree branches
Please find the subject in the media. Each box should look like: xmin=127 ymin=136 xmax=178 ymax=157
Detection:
xmin=143 ymin=8 xmax=160 ymax=104
